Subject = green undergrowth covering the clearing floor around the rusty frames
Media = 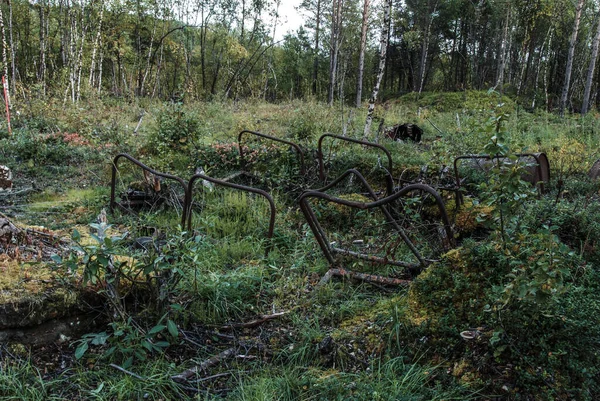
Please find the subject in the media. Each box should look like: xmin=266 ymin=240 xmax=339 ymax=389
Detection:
xmin=0 ymin=92 xmax=600 ymax=400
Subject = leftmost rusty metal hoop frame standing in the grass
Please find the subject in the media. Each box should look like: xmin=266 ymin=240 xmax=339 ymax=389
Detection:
xmin=110 ymin=153 xmax=188 ymax=227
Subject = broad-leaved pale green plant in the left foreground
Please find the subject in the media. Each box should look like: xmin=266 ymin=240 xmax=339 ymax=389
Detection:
xmin=52 ymin=214 xmax=183 ymax=366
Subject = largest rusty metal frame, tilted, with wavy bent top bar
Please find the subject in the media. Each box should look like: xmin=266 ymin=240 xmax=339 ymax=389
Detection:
xmin=299 ymin=170 xmax=454 ymax=274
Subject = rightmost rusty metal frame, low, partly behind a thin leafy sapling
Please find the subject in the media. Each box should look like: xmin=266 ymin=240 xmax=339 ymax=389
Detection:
xmin=454 ymin=153 xmax=550 ymax=202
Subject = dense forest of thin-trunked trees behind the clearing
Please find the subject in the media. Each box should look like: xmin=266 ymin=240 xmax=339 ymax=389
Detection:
xmin=0 ymin=0 xmax=600 ymax=112
